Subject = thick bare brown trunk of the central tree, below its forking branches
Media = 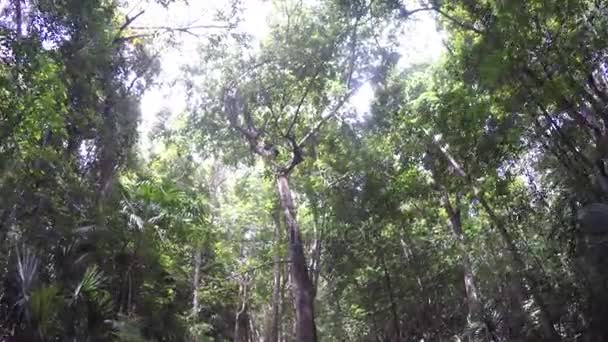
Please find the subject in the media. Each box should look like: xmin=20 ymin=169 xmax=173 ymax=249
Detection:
xmin=277 ymin=174 xmax=317 ymax=342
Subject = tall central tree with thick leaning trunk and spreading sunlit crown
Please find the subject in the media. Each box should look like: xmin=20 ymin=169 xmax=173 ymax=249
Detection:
xmin=185 ymin=1 xmax=394 ymax=341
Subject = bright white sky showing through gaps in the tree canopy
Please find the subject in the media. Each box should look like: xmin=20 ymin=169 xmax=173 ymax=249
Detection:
xmin=127 ymin=0 xmax=443 ymax=146
